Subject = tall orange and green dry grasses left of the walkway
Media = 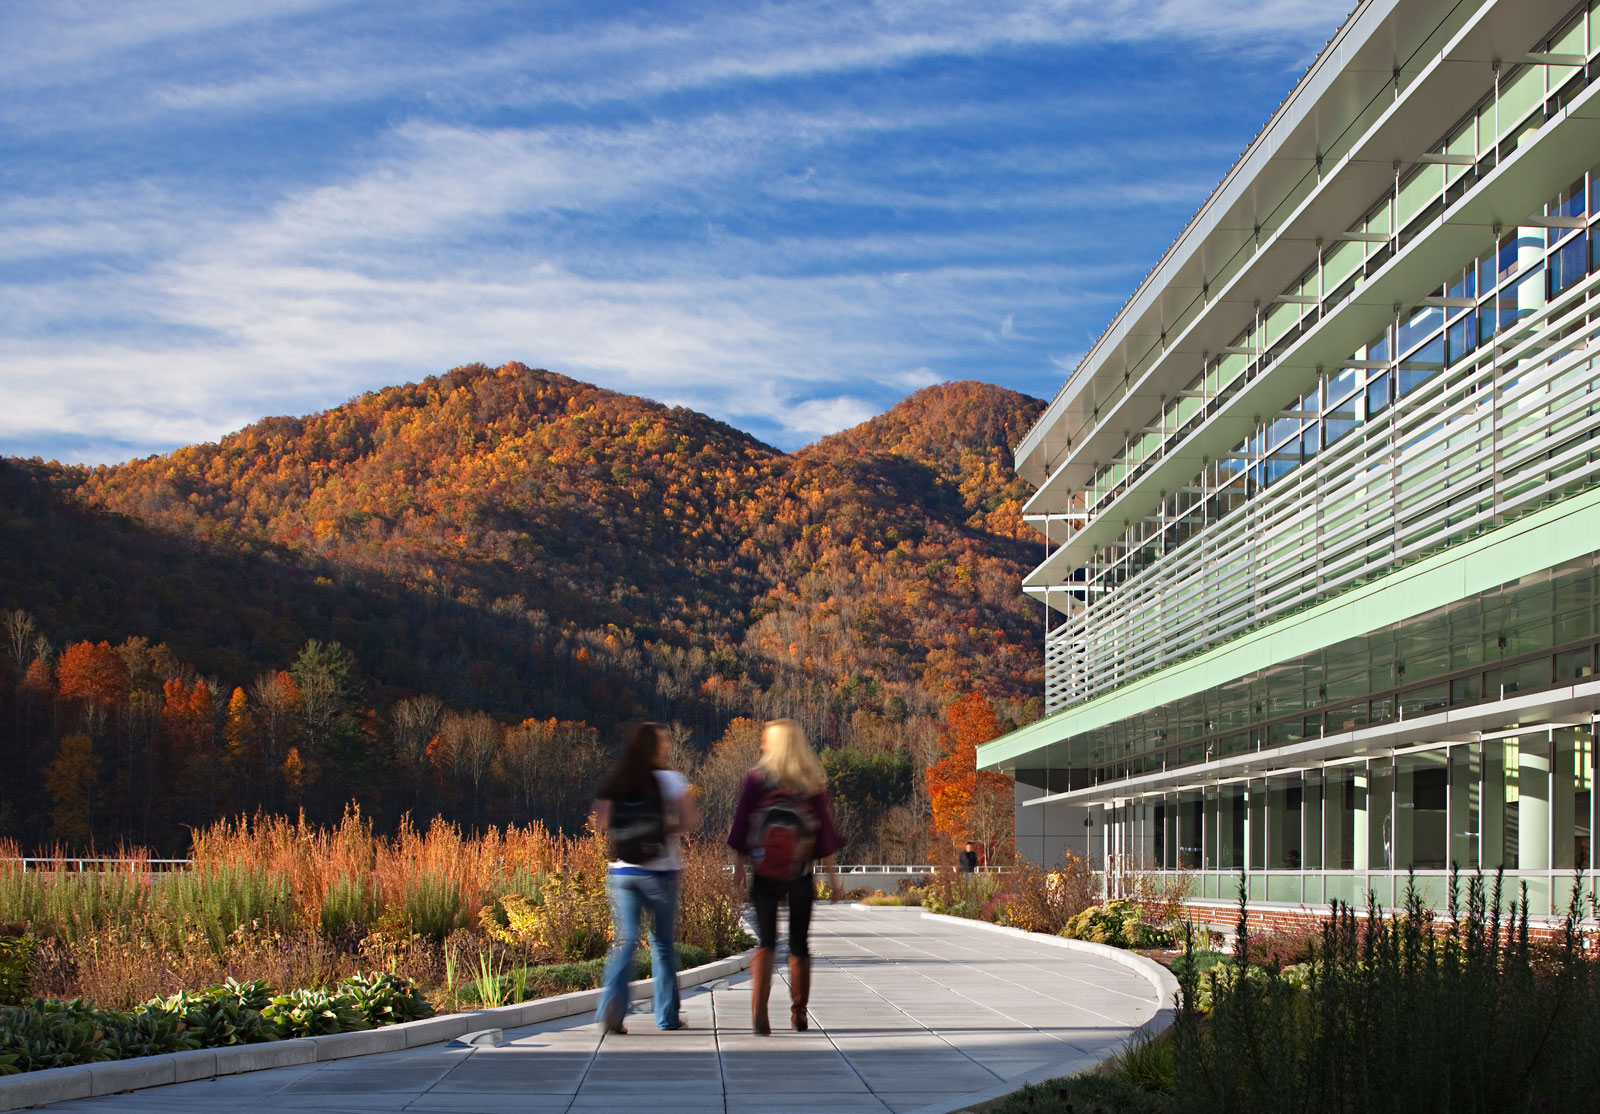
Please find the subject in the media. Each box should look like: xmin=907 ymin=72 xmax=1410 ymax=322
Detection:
xmin=0 ymin=808 xmax=741 ymax=1005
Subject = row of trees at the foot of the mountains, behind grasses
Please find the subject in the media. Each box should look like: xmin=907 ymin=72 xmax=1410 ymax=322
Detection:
xmin=0 ymin=610 xmax=1011 ymax=861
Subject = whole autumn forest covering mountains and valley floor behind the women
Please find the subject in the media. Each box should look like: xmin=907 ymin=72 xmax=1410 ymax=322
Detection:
xmin=0 ymin=363 xmax=1042 ymax=861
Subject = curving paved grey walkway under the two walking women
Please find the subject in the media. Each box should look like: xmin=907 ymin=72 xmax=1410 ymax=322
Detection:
xmin=40 ymin=906 xmax=1158 ymax=1114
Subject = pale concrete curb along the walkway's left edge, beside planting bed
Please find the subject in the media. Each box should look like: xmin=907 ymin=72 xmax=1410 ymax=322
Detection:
xmin=0 ymin=952 xmax=750 ymax=1111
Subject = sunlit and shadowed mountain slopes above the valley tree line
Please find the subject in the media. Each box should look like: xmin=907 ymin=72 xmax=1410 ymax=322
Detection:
xmin=0 ymin=363 xmax=1042 ymax=851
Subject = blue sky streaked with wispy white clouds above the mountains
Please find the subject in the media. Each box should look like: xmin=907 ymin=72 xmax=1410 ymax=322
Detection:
xmin=0 ymin=0 xmax=1352 ymax=464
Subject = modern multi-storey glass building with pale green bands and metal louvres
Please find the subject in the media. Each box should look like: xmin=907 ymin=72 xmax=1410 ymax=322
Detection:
xmin=978 ymin=0 xmax=1600 ymax=912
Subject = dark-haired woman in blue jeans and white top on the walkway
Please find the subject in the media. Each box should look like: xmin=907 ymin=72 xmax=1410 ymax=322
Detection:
xmin=594 ymin=723 xmax=699 ymax=1032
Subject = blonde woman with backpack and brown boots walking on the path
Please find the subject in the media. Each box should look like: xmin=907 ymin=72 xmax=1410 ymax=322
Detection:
xmin=728 ymin=719 xmax=838 ymax=1036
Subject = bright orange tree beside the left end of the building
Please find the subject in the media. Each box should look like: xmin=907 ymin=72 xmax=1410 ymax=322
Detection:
xmin=925 ymin=693 xmax=1011 ymax=860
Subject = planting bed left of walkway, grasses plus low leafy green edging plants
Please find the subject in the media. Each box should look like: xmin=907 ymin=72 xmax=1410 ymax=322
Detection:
xmin=0 ymin=810 xmax=749 ymax=1072
